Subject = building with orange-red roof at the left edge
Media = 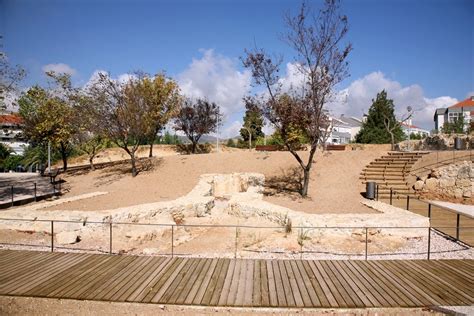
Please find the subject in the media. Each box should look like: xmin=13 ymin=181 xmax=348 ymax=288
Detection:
xmin=0 ymin=114 xmax=28 ymax=155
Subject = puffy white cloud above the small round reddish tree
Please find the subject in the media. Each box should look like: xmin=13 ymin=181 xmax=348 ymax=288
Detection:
xmin=177 ymin=50 xmax=251 ymax=114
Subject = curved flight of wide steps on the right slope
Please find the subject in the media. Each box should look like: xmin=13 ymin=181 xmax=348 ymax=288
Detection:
xmin=360 ymin=152 xmax=427 ymax=199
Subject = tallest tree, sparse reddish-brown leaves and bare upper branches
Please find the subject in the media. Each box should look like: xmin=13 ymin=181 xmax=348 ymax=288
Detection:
xmin=243 ymin=0 xmax=352 ymax=196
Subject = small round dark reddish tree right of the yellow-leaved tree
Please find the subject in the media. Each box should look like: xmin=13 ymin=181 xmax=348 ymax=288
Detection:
xmin=174 ymin=99 xmax=222 ymax=154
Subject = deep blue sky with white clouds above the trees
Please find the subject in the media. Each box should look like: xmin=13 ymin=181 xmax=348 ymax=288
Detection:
xmin=0 ymin=0 xmax=474 ymax=134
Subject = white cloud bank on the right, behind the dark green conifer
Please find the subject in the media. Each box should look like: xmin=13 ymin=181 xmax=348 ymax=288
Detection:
xmin=330 ymin=71 xmax=458 ymax=130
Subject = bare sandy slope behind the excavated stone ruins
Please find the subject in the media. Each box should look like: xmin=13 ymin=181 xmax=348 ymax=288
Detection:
xmin=45 ymin=147 xmax=386 ymax=213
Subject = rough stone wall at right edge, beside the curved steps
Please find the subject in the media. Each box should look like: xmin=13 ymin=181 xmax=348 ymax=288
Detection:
xmin=413 ymin=161 xmax=474 ymax=204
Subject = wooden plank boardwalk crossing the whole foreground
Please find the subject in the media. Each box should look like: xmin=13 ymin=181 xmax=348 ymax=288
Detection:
xmin=0 ymin=250 xmax=474 ymax=308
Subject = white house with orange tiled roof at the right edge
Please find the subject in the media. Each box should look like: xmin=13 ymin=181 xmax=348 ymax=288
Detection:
xmin=434 ymin=96 xmax=474 ymax=131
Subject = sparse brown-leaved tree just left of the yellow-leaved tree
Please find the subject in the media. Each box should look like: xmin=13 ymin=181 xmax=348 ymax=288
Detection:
xmin=89 ymin=73 xmax=149 ymax=177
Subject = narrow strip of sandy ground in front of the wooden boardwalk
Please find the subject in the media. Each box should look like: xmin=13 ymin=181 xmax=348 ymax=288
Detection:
xmin=0 ymin=296 xmax=444 ymax=316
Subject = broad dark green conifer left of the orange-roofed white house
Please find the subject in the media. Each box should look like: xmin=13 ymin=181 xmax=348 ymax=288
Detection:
xmin=356 ymin=90 xmax=404 ymax=144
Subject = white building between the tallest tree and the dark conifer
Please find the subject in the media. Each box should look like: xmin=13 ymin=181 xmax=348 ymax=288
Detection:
xmin=327 ymin=115 xmax=362 ymax=144
